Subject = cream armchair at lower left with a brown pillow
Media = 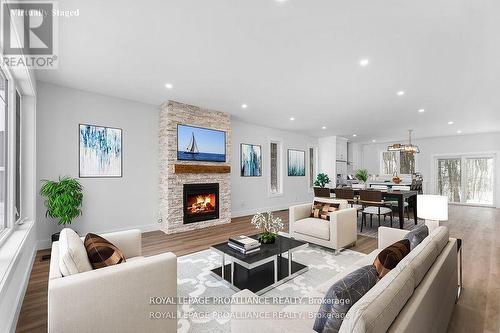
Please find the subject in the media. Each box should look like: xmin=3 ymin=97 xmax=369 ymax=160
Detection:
xmin=48 ymin=230 xmax=177 ymax=333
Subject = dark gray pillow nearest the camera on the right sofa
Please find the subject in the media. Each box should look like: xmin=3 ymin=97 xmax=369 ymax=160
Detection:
xmin=313 ymin=265 xmax=378 ymax=333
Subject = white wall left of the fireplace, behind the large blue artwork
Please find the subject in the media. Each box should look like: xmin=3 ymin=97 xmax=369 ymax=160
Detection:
xmin=36 ymin=82 xmax=159 ymax=247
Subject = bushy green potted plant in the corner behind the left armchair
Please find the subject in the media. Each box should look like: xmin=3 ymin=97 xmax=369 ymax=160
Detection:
xmin=40 ymin=177 xmax=83 ymax=242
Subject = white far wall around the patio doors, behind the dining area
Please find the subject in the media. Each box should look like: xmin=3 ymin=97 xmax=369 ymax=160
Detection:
xmin=363 ymin=133 xmax=500 ymax=207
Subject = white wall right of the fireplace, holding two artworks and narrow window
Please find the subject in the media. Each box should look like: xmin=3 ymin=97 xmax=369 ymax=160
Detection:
xmin=231 ymin=118 xmax=318 ymax=217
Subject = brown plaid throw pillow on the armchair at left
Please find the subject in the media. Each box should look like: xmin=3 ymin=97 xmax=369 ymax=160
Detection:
xmin=83 ymin=233 xmax=125 ymax=269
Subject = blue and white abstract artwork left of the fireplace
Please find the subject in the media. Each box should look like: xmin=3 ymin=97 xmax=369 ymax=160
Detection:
xmin=79 ymin=124 xmax=122 ymax=178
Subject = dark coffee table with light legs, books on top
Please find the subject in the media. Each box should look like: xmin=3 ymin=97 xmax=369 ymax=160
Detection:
xmin=210 ymin=235 xmax=308 ymax=295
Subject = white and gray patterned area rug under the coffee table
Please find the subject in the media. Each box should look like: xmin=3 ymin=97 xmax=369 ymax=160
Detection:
xmin=177 ymin=245 xmax=365 ymax=333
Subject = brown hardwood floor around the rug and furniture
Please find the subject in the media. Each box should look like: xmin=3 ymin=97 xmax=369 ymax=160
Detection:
xmin=13 ymin=206 xmax=500 ymax=332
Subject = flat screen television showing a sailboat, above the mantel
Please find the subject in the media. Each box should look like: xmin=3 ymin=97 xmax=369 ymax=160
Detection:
xmin=177 ymin=124 xmax=226 ymax=162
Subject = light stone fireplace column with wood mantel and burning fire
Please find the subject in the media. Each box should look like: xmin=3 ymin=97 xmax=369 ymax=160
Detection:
xmin=159 ymin=101 xmax=231 ymax=234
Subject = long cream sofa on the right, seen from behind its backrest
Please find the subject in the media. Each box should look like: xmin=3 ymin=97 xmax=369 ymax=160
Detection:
xmin=231 ymin=227 xmax=458 ymax=333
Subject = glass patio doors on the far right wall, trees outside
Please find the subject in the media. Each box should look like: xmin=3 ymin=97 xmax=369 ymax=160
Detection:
xmin=436 ymin=155 xmax=495 ymax=206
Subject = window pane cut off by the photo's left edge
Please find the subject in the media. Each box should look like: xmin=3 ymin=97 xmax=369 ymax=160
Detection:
xmin=0 ymin=70 xmax=9 ymax=231
